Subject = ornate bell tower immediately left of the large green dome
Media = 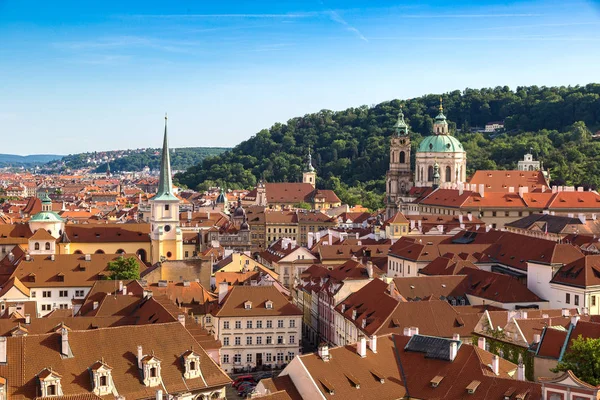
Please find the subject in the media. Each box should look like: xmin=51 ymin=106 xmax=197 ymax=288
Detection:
xmin=386 ymin=108 xmax=412 ymax=218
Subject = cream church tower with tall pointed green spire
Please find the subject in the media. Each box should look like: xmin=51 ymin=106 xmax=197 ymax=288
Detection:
xmin=150 ymin=115 xmax=183 ymax=262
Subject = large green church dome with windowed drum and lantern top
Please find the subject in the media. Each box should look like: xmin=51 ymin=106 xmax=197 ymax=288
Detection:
xmin=415 ymin=98 xmax=467 ymax=187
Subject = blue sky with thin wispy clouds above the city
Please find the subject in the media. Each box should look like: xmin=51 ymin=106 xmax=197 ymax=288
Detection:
xmin=0 ymin=0 xmax=600 ymax=154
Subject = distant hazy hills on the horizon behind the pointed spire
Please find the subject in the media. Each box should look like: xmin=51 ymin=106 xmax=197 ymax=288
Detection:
xmin=47 ymin=147 xmax=229 ymax=172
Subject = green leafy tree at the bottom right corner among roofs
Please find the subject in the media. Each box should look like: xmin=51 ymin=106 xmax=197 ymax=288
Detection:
xmin=551 ymin=335 xmax=600 ymax=386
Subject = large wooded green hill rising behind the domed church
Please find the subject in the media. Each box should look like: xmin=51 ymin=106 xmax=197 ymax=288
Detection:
xmin=176 ymin=84 xmax=600 ymax=208
